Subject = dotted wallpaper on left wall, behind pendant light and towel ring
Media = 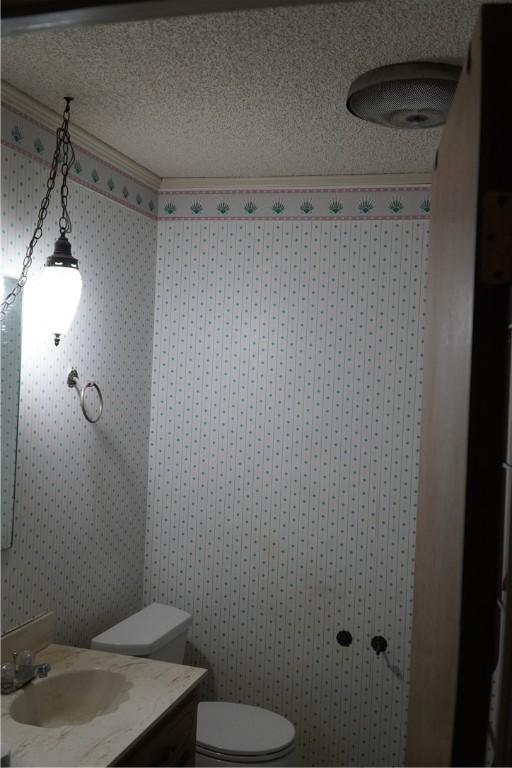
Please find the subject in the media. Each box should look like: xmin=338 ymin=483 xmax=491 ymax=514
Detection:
xmin=2 ymin=147 xmax=156 ymax=645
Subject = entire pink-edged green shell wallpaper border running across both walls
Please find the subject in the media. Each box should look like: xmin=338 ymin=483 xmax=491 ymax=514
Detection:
xmin=2 ymin=104 xmax=431 ymax=221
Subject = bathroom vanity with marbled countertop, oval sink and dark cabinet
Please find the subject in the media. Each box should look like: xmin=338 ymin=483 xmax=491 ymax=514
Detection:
xmin=2 ymin=620 xmax=206 ymax=766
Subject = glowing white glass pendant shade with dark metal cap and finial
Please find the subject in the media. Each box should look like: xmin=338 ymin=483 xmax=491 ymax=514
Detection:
xmin=40 ymin=235 xmax=82 ymax=346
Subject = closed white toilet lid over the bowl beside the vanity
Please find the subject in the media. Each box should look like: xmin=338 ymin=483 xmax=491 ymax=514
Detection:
xmin=196 ymin=701 xmax=295 ymax=755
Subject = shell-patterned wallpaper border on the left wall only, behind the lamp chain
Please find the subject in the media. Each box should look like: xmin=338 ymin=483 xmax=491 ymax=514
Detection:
xmin=2 ymin=103 xmax=158 ymax=219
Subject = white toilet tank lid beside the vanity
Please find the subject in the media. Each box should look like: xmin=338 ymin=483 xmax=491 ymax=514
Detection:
xmin=91 ymin=603 xmax=192 ymax=656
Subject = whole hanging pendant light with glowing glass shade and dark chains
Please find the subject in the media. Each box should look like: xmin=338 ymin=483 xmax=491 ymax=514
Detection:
xmin=0 ymin=96 xmax=82 ymax=346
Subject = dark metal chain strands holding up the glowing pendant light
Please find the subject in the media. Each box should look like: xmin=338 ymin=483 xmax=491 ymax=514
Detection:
xmin=0 ymin=97 xmax=75 ymax=317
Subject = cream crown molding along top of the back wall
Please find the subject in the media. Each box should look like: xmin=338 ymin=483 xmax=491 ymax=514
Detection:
xmin=160 ymin=173 xmax=432 ymax=192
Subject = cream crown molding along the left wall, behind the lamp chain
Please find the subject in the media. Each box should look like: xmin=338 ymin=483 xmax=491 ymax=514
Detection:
xmin=2 ymin=80 xmax=161 ymax=190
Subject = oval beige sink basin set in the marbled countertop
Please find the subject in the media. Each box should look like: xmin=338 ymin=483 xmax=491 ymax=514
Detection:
xmin=10 ymin=669 xmax=131 ymax=728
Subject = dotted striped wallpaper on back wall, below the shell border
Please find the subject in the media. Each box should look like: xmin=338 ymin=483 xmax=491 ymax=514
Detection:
xmin=144 ymin=214 xmax=429 ymax=765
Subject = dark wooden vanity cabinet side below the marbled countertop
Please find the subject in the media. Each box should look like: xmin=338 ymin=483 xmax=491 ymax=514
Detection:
xmin=111 ymin=691 xmax=199 ymax=768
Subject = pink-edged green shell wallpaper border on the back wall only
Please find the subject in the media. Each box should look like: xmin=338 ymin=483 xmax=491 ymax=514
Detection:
xmin=158 ymin=184 xmax=431 ymax=221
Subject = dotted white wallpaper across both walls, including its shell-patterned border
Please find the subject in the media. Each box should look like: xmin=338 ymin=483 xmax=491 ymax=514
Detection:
xmin=2 ymin=109 xmax=430 ymax=766
